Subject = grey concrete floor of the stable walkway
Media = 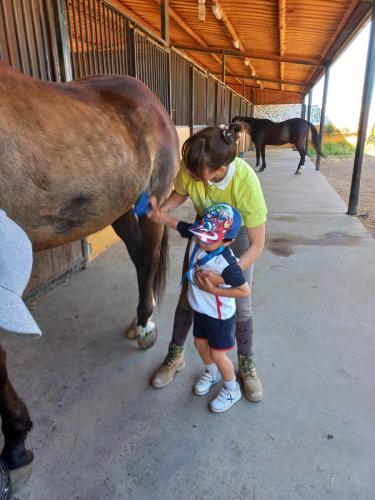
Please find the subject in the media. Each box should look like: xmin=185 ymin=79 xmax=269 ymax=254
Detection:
xmin=0 ymin=149 xmax=375 ymax=500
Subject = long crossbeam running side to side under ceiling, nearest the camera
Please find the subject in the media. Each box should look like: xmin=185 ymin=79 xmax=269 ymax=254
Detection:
xmin=175 ymin=45 xmax=324 ymax=68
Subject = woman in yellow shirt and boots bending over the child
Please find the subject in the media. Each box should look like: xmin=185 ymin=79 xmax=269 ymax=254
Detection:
xmin=152 ymin=123 xmax=267 ymax=401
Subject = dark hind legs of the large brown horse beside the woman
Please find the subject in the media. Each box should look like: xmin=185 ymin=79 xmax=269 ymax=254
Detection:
xmin=112 ymin=211 xmax=164 ymax=349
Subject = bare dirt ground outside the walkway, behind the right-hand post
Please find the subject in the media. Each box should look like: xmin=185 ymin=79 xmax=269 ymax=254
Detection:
xmin=320 ymin=155 xmax=375 ymax=237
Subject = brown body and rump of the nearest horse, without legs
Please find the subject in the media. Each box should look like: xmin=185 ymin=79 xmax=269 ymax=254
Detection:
xmin=0 ymin=64 xmax=178 ymax=248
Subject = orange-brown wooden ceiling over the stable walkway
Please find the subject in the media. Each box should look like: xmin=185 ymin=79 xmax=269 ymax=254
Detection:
xmin=112 ymin=0 xmax=372 ymax=103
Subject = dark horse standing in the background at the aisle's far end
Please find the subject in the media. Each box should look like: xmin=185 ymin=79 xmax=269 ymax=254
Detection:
xmin=232 ymin=116 xmax=323 ymax=174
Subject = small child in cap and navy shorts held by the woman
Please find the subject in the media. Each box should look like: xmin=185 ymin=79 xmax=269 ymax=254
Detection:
xmin=150 ymin=198 xmax=250 ymax=412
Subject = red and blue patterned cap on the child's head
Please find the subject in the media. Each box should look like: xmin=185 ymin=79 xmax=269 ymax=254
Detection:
xmin=189 ymin=203 xmax=242 ymax=245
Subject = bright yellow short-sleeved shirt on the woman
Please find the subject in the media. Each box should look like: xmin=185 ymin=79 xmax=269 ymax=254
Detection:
xmin=174 ymin=158 xmax=267 ymax=228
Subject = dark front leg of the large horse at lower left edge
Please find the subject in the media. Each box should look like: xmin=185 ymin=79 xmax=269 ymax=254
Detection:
xmin=0 ymin=345 xmax=34 ymax=469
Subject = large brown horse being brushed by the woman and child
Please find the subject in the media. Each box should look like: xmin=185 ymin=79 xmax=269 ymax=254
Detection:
xmin=0 ymin=62 xmax=179 ymax=468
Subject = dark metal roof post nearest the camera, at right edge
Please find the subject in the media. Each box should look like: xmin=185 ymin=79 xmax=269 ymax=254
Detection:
xmin=348 ymin=0 xmax=375 ymax=215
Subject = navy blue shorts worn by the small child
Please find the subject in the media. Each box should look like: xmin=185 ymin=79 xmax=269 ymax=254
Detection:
xmin=193 ymin=311 xmax=236 ymax=351
